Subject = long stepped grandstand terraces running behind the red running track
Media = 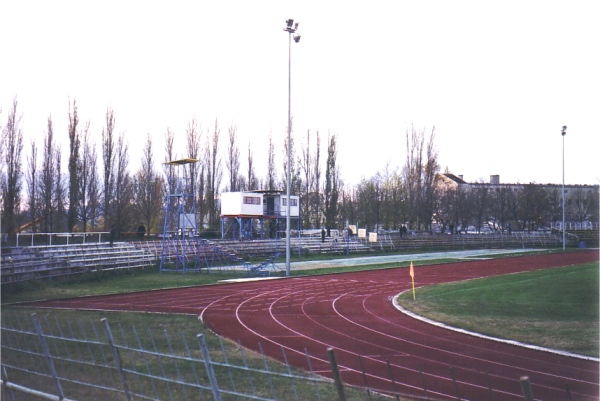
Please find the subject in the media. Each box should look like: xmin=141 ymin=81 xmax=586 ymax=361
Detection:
xmin=0 ymin=230 xmax=580 ymax=283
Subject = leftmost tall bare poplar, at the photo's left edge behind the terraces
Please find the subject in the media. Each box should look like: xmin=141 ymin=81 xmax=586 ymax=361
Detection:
xmin=0 ymin=98 xmax=23 ymax=236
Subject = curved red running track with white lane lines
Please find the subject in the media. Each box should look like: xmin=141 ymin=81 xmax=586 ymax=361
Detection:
xmin=28 ymin=251 xmax=600 ymax=401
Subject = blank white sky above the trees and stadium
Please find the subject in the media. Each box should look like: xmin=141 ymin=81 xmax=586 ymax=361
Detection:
xmin=0 ymin=0 xmax=600 ymax=184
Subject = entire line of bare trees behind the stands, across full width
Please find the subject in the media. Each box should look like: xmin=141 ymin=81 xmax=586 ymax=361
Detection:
xmin=0 ymin=99 xmax=598 ymax=241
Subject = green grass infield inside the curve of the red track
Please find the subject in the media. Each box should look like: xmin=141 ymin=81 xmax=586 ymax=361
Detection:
xmin=399 ymin=263 xmax=600 ymax=357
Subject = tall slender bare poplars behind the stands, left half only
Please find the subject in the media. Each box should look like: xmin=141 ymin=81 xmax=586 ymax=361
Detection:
xmin=1 ymin=98 xmax=341 ymax=239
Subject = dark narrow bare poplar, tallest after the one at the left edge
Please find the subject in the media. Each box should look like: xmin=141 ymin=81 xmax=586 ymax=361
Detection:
xmin=67 ymin=100 xmax=81 ymax=231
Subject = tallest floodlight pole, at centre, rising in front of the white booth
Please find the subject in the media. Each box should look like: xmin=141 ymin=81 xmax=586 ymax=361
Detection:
xmin=283 ymin=18 xmax=300 ymax=276
